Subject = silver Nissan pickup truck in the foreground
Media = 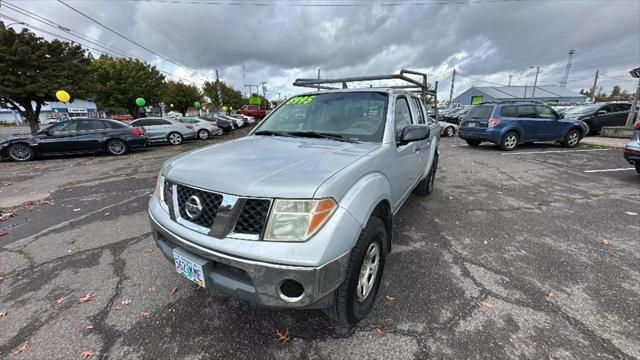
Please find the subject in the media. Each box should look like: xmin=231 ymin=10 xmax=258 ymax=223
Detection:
xmin=149 ymin=88 xmax=440 ymax=325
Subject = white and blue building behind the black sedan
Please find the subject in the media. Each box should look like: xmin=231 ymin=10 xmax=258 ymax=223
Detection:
xmin=0 ymin=99 xmax=104 ymax=125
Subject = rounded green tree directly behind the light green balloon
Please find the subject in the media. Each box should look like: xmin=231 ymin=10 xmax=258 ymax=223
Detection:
xmin=91 ymin=55 xmax=164 ymax=117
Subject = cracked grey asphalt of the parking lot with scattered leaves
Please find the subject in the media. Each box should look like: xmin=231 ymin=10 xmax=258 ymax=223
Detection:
xmin=0 ymin=130 xmax=640 ymax=359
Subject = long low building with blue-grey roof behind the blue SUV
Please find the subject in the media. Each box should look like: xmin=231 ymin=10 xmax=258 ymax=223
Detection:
xmin=453 ymin=85 xmax=587 ymax=105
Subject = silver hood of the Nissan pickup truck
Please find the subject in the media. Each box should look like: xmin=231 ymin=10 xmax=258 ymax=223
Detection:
xmin=163 ymin=136 xmax=379 ymax=198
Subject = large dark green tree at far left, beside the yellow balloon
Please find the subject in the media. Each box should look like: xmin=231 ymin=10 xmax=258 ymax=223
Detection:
xmin=0 ymin=22 xmax=91 ymax=133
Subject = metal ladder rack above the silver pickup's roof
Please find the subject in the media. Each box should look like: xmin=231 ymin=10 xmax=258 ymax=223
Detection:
xmin=293 ymin=69 xmax=438 ymax=104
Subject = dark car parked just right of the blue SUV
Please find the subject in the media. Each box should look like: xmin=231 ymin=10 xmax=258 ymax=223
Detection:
xmin=564 ymin=102 xmax=631 ymax=135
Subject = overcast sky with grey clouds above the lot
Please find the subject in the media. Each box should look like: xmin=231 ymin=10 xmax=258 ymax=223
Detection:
xmin=0 ymin=0 xmax=640 ymax=100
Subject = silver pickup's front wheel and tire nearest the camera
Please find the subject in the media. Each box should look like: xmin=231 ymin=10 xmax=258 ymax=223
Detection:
xmin=325 ymin=216 xmax=387 ymax=327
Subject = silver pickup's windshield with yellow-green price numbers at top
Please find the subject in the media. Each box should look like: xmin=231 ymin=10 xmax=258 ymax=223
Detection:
xmin=256 ymin=92 xmax=387 ymax=142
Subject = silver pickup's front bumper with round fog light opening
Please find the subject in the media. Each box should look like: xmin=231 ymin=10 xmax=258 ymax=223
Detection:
xmin=149 ymin=211 xmax=350 ymax=308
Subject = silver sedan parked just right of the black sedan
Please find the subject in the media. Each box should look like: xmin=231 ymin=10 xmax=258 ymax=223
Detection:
xmin=131 ymin=117 xmax=196 ymax=145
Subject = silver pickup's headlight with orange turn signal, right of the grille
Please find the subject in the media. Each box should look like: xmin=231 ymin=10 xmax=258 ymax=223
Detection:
xmin=264 ymin=198 xmax=338 ymax=241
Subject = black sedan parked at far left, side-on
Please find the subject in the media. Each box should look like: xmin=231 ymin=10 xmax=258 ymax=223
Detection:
xmin=0 ymin=119 xmax=147 ymax=161
